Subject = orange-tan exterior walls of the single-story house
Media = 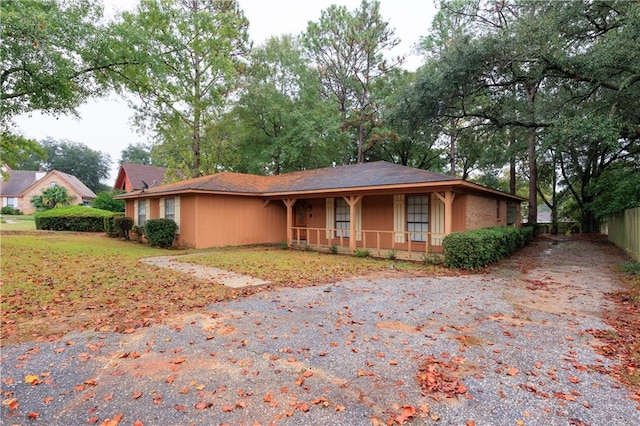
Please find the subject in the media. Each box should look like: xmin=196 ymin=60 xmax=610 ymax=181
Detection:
xmin=125 ymin=190 xmax=520 ymax=251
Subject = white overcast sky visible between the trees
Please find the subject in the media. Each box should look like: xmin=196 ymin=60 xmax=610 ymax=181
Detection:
xmin=15 ymin=0 xmax=436 ymax=185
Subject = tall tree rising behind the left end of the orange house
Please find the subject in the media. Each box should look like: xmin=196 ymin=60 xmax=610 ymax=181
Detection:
xmin=118 ymin=0 xmax=248 ymax=177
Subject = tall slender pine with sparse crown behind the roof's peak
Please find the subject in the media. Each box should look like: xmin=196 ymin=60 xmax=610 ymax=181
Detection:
xmin=303 ymin=0 xmax=401 ymax=163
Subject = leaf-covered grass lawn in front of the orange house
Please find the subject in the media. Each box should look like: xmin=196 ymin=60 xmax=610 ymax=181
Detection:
xmin=0 ymin=230 xmax=446 ymax=345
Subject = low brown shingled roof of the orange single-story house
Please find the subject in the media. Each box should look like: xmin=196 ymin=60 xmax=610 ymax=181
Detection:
xmin=118 ymin=161 xmax=519 ymax=199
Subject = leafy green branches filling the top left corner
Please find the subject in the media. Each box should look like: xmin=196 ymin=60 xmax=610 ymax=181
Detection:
xmin=0 ymin=0 xmax=125 ymax=121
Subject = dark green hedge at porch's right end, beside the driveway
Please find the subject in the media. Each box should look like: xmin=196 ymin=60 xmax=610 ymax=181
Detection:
xmin=442 ymin=226 xmax=534 ymax=270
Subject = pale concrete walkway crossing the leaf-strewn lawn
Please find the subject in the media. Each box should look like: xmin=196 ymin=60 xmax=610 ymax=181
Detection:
xmin=140 ymin=256 xmax=270 ymax=288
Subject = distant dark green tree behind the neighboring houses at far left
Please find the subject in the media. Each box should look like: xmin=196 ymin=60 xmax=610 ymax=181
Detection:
xmin=41 ymin=138 xmax=111 ymax=193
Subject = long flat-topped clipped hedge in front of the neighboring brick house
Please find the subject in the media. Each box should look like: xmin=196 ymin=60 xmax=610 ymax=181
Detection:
xmin=34 ymin=206 xmax=114 ymax=232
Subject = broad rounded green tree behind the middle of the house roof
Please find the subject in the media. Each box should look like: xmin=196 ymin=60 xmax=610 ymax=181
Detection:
xmin=233 ymin=35 xmax=345 ymax=174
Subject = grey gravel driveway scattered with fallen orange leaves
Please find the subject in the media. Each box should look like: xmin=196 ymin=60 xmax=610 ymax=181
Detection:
xmin=0 ymin=235 xmax=640 ymax=426
